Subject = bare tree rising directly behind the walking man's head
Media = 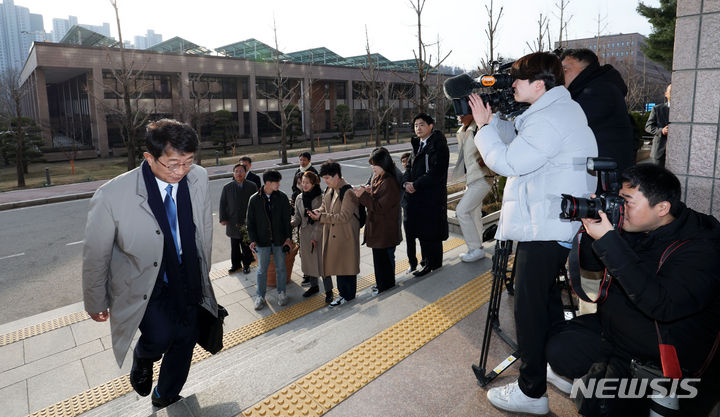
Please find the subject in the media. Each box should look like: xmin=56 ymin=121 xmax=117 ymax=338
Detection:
xmin=108 ymin=0 xmax=149 ymax=171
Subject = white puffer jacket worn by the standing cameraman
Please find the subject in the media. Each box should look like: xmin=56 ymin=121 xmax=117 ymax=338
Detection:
xmin=475 ymin=86 xmax=598 ymax=242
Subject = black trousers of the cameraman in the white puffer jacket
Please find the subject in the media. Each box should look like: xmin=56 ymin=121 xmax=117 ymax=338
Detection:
xmin=514 ymin=241 xmax=570 ymax=398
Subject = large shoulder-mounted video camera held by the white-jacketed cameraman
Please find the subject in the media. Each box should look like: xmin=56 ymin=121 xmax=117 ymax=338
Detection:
xmin=443 ymin=61 xmax=529 ymax=120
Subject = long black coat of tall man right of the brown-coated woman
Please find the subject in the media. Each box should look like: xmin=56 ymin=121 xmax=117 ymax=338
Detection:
xmin=402 ymin=130 xmax=450 ymax=241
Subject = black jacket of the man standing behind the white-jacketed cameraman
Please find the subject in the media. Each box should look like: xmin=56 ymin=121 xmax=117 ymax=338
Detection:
xmin=568 ymin=65 xmax=635 ymax=172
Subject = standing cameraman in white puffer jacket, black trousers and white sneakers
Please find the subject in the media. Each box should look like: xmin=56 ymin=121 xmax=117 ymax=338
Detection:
xmin=470 ymin=52 xmax=597 ymax=414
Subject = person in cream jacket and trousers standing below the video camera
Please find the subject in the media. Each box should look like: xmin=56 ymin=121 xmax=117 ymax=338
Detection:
xmin=452 ymin=110 xmax=492 ymax=262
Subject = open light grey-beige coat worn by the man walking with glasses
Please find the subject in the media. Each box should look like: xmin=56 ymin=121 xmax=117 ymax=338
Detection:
xmin=82 ymin=162 xmax=217 ymax=366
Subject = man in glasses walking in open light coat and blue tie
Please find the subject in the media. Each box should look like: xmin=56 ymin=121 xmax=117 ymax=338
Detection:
xmin=82 ymin=119 xmax=217 ymax=408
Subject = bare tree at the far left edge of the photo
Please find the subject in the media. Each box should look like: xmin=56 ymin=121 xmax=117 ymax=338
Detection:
xmin=0 ymin=67 xmax=25 ymax=187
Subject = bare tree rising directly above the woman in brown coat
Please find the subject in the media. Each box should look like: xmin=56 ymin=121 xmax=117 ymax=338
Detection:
xmin=360 ymin=26 xmax=392 ymax=146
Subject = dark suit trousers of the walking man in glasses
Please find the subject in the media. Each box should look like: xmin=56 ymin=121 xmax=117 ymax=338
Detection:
xmin=135 ymin=285 xmax=202 ymax=398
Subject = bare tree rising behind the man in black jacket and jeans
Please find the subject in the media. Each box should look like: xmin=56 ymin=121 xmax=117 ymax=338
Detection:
xmin=258 ymin=17 xmax=300 ymax=165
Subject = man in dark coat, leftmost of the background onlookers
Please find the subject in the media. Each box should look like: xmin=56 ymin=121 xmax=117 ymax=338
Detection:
xmin=218 ymin=163 xmax=257 ymax=274
